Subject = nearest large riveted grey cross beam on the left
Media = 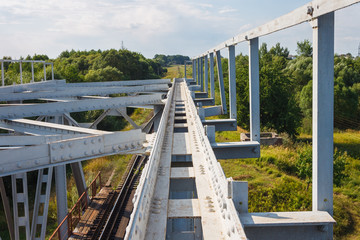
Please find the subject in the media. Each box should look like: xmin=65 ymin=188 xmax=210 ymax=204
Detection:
xmin=0 ymin=129 xmax=146 ymax=177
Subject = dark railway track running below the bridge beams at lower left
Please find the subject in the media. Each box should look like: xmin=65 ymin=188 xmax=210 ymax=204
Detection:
xmin=85 ymin=155 xmax=147 ymax=240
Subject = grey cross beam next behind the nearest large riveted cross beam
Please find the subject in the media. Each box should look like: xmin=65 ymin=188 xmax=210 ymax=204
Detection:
xmin=0 ymin=94 xmax=162 ymax=119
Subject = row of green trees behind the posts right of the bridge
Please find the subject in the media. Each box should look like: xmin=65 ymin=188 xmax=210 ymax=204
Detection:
xmin=217 ymin=40 xmax=360 ymax=138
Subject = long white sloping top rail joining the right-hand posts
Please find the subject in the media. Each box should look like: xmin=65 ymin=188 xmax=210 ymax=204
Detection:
xmin=193 ymin=0 xmax=360 ymax=58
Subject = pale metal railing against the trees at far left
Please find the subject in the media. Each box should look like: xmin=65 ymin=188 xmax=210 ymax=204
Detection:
xmin=0 ymin=59 xmax=54 ymax=86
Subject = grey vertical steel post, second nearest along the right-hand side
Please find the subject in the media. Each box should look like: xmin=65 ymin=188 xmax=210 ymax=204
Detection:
xmin=249 ymin=38 xmax=260 ymax=142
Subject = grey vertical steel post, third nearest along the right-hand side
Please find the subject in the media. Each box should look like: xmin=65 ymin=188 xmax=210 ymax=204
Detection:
xmin=228 ymin=46 xmax=237 ymax=119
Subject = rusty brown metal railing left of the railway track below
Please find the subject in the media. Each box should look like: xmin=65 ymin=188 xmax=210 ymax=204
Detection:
xmin=49 ymin=172 xmax=102 ymax=240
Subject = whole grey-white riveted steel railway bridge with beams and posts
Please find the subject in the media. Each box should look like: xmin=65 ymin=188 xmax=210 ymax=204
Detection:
xmin=0 ymin=0 xmax=359 ymax=240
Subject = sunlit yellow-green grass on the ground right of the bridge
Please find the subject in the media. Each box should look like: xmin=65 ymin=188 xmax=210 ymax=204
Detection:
xmin=216 ymin=129 xmax=360 ymax=240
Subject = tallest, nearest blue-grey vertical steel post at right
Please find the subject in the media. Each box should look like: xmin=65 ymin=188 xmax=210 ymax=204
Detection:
xmin=312 ymin=12 xmax=334 ymax=218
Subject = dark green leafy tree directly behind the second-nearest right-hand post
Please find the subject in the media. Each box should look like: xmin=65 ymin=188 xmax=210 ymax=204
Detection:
xmin=236 ymin=43 xmax=301 ymax=137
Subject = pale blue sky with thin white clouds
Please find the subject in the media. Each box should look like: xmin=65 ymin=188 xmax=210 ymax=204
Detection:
xmin=0 ymin=0 xmax=360 ymax=59
